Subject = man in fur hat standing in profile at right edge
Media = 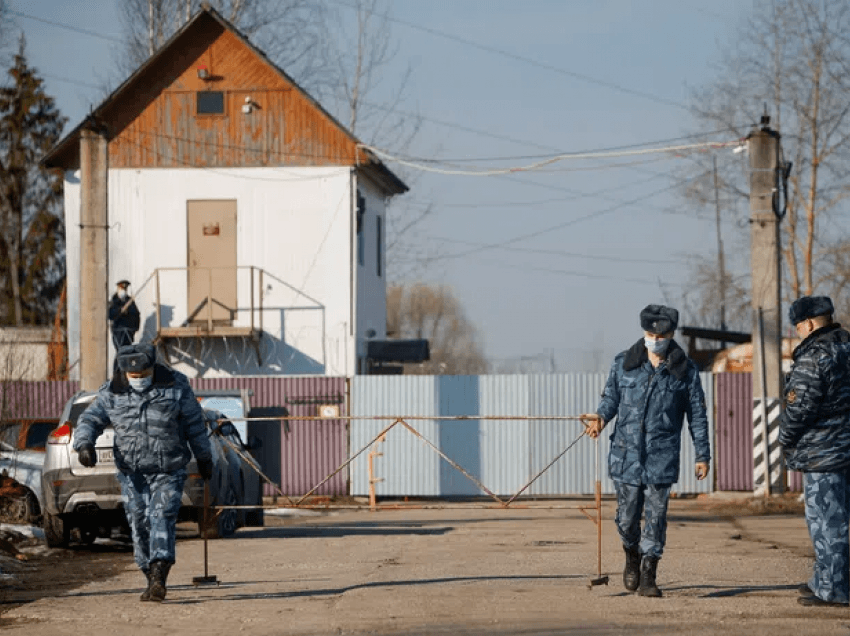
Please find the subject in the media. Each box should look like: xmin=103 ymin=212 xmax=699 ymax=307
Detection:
xmin=779 ymin=296 xmax=850 ymax=607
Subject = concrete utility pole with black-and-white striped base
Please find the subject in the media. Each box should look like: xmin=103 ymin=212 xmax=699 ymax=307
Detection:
xmin=747 ymin=114 xmax=784 ymax=496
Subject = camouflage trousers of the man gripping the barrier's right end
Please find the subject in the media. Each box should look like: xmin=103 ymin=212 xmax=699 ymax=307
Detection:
xmin=614 ymin=481 xmax=672 ymax=559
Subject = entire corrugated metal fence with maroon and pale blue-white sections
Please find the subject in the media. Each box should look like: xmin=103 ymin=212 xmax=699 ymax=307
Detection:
xmin=0 ymin=373 xmax=801 ymax=496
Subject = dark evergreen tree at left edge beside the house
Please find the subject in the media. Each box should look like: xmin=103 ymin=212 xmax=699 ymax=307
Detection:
xmin=0 ymin=36 xmax=66 ymax=326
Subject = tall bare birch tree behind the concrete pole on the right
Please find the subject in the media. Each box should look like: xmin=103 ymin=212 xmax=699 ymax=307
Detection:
xmin=690 ymin=0 xmax=850 ymax=320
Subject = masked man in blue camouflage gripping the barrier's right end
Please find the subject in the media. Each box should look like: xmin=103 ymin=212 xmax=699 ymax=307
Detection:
xmin=582 ymin=305 xmax=711 ymax=597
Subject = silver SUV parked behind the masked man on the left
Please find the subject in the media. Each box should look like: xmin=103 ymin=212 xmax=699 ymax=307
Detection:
xmin=41 ymin=391 xmax=263 ymax=547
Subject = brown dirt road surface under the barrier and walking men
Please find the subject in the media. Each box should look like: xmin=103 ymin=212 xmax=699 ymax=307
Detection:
xmin=0 ymin=495 xmax=850 ymax=636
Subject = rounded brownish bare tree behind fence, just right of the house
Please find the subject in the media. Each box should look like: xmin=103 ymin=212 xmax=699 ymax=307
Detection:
xmin=387 ymin=283 xmax=488 ymax=375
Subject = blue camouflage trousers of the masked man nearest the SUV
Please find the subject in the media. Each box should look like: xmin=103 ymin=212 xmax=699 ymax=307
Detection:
xmin=118 ymin=468 xmax=186 ymax=572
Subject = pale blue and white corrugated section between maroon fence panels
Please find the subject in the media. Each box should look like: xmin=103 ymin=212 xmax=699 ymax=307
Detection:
xmin=350 ymin=374 xmax=714 ymax=497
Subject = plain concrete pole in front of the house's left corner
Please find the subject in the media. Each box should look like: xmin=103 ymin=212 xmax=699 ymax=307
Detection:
xmin=80 ymin=126 xmax=109 ymax=391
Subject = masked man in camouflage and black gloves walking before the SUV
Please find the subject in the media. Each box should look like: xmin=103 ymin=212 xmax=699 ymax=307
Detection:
xmin=74 ymin=344 xmax=213 ymax=602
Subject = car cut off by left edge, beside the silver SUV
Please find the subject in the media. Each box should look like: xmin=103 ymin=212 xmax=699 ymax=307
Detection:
xmin=0 ymin=419 xmax=57 ymax=524
